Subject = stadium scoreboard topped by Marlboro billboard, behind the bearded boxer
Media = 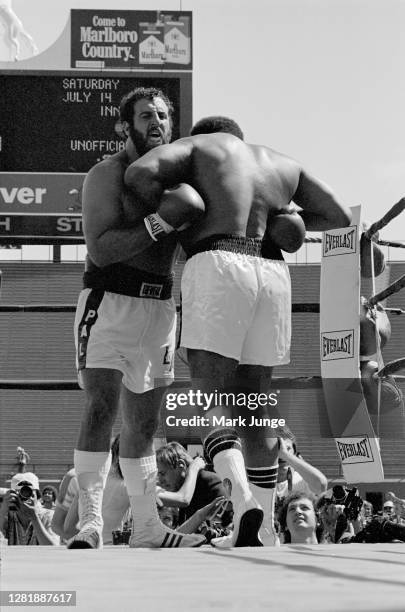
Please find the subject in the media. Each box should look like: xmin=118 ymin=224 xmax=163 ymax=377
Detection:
xmin=0 ymin=10 xmax=192 ymax=245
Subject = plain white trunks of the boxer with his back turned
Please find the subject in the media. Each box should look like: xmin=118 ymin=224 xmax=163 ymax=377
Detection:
xmin=180 ymin=237 xmax=291 ymax=367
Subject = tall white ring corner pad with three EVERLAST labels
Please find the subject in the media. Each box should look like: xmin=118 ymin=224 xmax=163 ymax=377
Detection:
xmin=320 ymin=206 xmax=384 ymax=483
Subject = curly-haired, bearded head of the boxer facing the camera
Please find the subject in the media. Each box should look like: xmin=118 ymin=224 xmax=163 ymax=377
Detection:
xmin=120 ymin=87 xmax=174 ymax=156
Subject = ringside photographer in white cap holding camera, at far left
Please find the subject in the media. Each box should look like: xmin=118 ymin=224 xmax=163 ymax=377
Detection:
xmin=0 ymin=472 xmax=60 ymax=546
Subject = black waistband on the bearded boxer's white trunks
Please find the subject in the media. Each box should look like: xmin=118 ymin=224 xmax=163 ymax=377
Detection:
xmin=83 ymin=262 xmax=174 ymax=300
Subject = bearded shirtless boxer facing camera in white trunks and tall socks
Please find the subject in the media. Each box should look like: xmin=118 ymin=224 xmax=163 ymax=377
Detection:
xmin=68 ymin=88 xmax=204 ymax=548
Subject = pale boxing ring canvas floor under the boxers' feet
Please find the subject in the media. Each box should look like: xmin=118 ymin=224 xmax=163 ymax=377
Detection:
xmin=1 ymin=543 xmax=405 ymax=612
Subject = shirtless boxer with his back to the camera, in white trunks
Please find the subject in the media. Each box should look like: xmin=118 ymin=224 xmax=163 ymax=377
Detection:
xmin=125 ymin=117 xmax=351 ymax=546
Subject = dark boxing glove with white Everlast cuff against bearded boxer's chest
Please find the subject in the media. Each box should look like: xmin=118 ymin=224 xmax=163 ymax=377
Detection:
xmin=144 ymin=183 xmax=205 ymax=241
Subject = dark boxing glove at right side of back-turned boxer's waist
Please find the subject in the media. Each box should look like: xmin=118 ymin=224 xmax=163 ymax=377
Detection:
xmin=267 ymin=209 xmax=305 ymax=253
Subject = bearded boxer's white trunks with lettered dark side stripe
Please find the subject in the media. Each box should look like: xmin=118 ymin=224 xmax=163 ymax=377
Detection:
xmin=74 ymin=288 xmax=176 ymax=393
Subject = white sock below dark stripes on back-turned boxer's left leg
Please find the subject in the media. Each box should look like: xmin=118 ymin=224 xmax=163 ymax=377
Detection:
xmin=214 ymin=448 xmax=252 ymax=509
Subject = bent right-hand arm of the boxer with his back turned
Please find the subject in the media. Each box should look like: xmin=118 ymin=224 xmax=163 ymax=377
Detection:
xmin=292 ymin=168 xmax=351 ymax=231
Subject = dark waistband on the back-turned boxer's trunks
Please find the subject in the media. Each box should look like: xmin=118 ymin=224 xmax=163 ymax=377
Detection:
xmin=186 ymin=234 xmax=284 ymax=261
